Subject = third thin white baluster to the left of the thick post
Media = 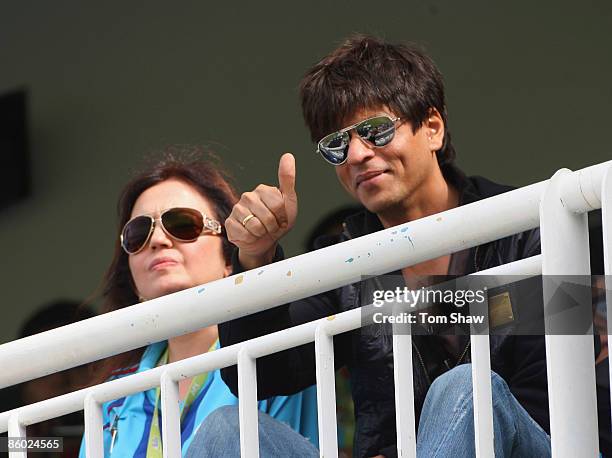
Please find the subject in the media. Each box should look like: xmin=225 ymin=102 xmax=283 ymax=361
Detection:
xmin=315 ymin=317 xmax=338 ymax=458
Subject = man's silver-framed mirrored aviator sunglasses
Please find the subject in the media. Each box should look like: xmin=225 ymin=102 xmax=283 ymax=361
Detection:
xmin=317 ymin=115 xmax=400 ymax=165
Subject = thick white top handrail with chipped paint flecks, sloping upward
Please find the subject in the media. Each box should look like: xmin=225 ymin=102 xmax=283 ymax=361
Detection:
xmin=0 ymin=156 xmax=592 ymax=388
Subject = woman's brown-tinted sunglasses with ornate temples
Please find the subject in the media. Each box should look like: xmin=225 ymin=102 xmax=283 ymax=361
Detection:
xmin=119 ymin=208 xmax=221 ymax=254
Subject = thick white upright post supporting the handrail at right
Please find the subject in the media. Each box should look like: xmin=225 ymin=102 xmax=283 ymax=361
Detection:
xmin=540 ymin=170 xmax=599 ymax=458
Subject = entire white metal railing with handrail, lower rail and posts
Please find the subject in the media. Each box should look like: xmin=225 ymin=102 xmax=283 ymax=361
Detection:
xmin=0 ymin=161 xmax=612 ymax=458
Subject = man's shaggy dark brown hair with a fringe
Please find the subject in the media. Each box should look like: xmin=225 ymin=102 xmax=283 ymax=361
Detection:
xmin=300 ymin=34 xmax=455 ymax=168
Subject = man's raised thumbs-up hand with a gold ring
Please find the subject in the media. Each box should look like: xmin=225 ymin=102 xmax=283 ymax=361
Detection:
xmin=225 ymin=153 xmax=298 ymax=269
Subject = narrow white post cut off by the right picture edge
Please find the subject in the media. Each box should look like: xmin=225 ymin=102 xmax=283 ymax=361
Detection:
xmin=601 ymin=166 xmax=612 ymax=430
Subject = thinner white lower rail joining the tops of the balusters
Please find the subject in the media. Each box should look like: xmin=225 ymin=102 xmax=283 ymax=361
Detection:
xmin=0 ymin=255 xmax=541 ymax=433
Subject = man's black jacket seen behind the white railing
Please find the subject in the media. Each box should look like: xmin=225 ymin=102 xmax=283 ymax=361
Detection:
xmin=219 ymin=168 xmax=549 ymax=457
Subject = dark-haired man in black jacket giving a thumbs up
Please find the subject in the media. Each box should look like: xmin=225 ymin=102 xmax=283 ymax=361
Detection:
xmin=194 ymin=36 xmax=550 ymax=457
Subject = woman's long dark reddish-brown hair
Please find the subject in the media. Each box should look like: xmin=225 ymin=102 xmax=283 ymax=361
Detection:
xmin=96 ymin=146 xmax=237 ymax=380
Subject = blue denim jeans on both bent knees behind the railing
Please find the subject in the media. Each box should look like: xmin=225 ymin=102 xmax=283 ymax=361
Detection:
xmin=187 ymin=364 xmax=551 ymax=458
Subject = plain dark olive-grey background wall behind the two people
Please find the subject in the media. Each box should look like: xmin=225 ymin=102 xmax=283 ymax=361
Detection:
xmin=0 ymin=0 xmax=612 ymax=341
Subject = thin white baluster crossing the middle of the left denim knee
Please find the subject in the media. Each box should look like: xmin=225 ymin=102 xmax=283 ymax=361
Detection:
xmin=238 ymin=346 xmax=259 ymax=458
